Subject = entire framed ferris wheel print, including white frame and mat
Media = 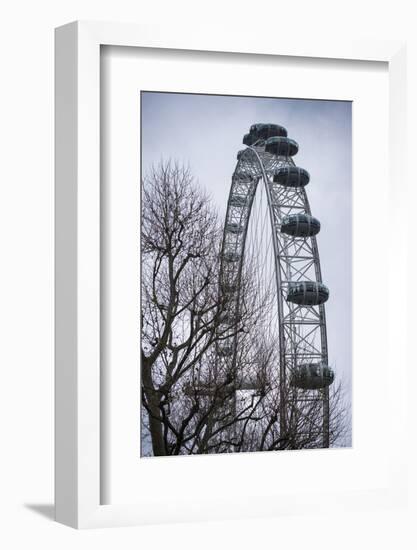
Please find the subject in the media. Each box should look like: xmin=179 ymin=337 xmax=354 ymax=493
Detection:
xmin=56 ymin=23 xmax=406 ymax=527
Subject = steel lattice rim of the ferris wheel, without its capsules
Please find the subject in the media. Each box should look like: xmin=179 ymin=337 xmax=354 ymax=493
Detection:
xmin=219 ymin=140 xmax=329 ymax=447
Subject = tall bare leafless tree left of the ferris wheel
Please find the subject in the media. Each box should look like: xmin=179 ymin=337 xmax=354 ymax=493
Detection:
xmin=142 ymin=162 xmax=231 ymax=455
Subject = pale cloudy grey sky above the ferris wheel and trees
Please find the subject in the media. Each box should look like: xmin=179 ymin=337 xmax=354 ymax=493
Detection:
xmin=141 ymin=92 xmax=352 ymax=440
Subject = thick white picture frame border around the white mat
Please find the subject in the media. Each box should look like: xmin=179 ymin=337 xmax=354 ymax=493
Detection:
xmin=56 ymin=22 xmax=406 ymax=528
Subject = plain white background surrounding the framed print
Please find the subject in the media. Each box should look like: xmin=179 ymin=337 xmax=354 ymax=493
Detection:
xmin=0 ymin=0 xmax=417 ymax=550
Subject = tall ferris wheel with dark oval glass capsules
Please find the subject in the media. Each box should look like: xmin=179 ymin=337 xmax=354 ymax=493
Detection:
xmin=217 ymin=124 xmax=334 ymax=447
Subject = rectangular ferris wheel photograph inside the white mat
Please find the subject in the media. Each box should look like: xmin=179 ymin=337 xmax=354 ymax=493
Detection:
xmin=138 ymin=90 xmax=352 ymax=457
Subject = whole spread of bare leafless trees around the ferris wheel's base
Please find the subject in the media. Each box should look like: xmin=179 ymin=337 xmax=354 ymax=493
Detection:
xmin=141 ymin=162 xmax=346 ymax=456
